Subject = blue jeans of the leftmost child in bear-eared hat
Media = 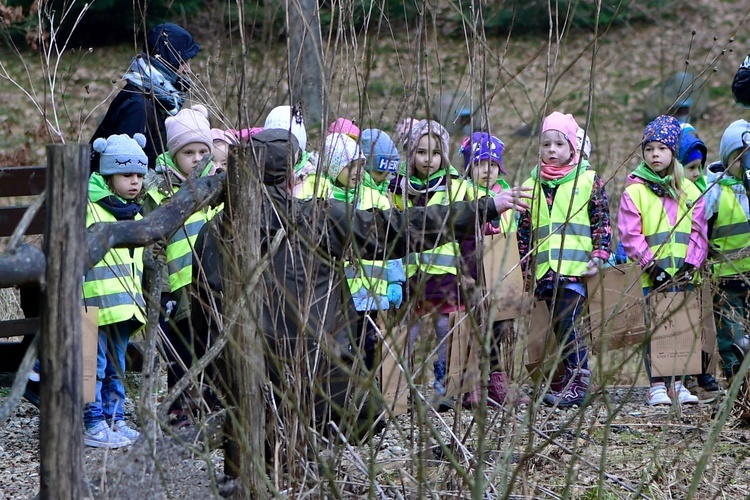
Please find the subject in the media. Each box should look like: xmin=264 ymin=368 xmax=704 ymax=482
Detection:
xmin=83 ymin=320 xmax=141 ymax=428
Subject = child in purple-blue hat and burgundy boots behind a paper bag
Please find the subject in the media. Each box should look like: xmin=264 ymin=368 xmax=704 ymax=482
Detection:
xmin=460 ymin=132 xmax=529 ymax=408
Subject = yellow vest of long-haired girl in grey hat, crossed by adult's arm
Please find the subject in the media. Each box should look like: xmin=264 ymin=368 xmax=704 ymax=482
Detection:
xmin=394 ymin=178 xmax=469 ymax=278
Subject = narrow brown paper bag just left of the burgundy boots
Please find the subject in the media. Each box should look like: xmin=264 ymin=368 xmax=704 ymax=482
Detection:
xmin=445 ymin=311 xmax=481 ymax=396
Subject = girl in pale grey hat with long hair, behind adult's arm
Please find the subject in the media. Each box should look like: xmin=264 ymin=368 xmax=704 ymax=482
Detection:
xmin=391 ymin=120 xmax=473 ymax=396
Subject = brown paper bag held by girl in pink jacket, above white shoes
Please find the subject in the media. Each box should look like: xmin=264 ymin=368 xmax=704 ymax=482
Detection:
xmin=648 ymin=290 xmax=703 ymax=377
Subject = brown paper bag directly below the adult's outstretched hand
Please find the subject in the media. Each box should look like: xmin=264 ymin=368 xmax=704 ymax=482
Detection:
xmin=482 ymin=231 xmax=524 ymax=321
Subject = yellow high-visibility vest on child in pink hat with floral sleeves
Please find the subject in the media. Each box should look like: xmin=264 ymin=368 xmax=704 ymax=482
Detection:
xmin=523 ymin=170 xmax=596 ymax=279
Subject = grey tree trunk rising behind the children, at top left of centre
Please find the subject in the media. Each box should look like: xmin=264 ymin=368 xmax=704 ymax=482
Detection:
xmin=287 ymin=0 xmax=327 ymax=127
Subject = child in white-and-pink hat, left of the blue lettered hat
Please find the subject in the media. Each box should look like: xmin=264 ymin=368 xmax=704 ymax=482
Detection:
xmin=323 ymin=133 xmax=406 ymax=370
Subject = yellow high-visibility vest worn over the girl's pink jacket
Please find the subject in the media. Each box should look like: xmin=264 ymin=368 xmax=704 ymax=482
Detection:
xmin=625 ymin=179 xmax=701 ymax=288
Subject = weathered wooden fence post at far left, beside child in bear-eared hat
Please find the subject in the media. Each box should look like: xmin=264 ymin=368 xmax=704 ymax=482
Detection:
xmin=39 ymin=144 xmax=90 ymax=499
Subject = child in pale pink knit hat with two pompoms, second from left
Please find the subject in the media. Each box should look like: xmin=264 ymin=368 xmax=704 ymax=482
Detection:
xmin=146 ymin=104 xmax=215 ymax=427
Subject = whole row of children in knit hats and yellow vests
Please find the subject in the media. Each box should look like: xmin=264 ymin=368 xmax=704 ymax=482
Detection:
xmin=84 ymin=96 xmax=750 ymax=448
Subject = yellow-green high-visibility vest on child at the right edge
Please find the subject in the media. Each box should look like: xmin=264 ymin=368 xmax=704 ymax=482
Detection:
xmin=711 ymin=185 xmax=750 ymax=277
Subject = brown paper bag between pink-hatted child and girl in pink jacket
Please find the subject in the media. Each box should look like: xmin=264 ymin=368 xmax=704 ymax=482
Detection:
xmin=582 ymin=264 xmax=646 ymax=353
